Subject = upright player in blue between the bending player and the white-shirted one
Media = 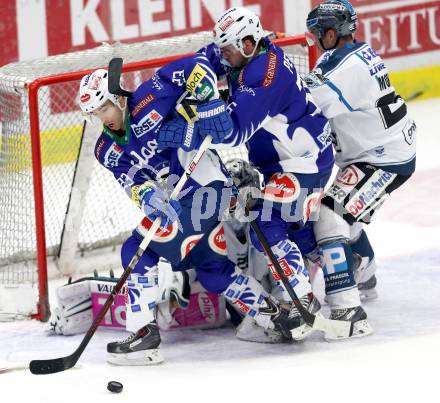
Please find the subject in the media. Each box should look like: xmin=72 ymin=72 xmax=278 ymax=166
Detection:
xmin=158 ymin=7 xmax=334 ymax=339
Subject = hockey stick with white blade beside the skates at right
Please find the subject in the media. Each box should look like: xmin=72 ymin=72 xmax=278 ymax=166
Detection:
xmin=217 ymin=153 xmax=353 ymax=337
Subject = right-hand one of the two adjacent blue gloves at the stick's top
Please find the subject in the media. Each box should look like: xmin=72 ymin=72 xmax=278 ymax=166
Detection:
xmin=197 ymin=99 xmax=234 ymax=144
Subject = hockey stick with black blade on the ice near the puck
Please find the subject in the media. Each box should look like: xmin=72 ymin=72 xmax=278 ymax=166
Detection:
xmin=29 ymin=136 xmax=212 ymax=375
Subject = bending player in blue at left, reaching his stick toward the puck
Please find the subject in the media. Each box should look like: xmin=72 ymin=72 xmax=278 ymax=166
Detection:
xmin=79 ymin=55 xmax=300 ymax=365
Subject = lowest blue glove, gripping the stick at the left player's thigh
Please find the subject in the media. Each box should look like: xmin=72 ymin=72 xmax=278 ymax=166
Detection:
xmin=138 ymin=182 xmax=182 ymax=228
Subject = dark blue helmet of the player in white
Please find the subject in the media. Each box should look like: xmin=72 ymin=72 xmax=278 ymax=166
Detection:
xmin=306 ymin=0 xmax=357 ymax=39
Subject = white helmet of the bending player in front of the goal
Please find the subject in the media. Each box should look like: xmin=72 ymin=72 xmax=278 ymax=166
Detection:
xmin=78 ymin=69 xmax=119 ymax=114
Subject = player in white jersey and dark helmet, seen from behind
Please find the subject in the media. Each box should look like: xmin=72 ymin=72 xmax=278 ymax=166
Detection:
xmin=306 ymin=0 xmax=416 ymax=336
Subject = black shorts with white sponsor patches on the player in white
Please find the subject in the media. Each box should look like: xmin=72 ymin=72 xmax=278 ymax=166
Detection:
xmin=322 ymin=163 xmax=411 ymax=224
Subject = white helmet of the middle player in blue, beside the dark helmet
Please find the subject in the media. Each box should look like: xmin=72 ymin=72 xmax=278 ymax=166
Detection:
xmin=214 ymin=7 xmax=264 ymax=57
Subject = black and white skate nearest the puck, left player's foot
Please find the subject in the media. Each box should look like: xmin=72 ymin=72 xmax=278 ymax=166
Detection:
xmin=107 ymin=322 xmax=163 ymax=366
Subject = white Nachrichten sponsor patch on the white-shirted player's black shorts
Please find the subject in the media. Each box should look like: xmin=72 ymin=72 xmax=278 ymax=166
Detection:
xmin=345 ymin=169 xmax=396 ymax=217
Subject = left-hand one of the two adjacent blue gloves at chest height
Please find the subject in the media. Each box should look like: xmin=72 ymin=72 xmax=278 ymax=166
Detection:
xmin=157 ymin=116 xmax=203 ymax=152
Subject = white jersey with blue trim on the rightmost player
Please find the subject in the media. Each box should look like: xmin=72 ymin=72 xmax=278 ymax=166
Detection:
xmin=306 ymin=42 xmax=416 ymax=175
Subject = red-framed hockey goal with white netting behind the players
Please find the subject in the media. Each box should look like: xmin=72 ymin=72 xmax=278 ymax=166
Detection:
xmin=0 ymin=32 xmax=316 ymax=321
